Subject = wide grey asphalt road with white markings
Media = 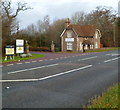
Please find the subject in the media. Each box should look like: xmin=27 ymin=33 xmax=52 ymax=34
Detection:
xmin=0 ymin=51 xmax=120 ymax=108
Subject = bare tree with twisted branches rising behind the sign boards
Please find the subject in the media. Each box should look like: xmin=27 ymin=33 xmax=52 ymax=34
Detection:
xmin=2 ymin=0 xmax=31 ymax=45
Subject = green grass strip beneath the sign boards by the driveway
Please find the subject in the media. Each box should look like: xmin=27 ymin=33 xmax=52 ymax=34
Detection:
xmin=2 ymin=54 xmax=45 ymax=63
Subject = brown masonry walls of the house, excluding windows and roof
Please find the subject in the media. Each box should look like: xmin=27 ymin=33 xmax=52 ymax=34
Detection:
xmin=61 ymin=30 xmax=101 ymax=52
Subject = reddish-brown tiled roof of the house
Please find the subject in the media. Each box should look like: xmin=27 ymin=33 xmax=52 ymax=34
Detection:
xmin=67 ymin=24 xmax=96 ymax=37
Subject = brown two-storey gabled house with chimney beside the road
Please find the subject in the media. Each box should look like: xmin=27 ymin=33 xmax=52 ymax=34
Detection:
xmin=60 ymin=18 xmax=101 ymax=52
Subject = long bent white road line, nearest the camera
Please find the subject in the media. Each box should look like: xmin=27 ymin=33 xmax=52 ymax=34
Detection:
xmin=0 ymin=65 xmax=92 ymax=82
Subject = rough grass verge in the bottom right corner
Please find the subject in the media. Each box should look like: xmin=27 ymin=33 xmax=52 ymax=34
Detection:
xmin=87 ymin=83 xmax=120 ymax=108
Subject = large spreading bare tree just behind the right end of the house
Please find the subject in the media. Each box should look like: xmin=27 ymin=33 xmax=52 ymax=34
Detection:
xmin=85 ymin=6 xmax=116 ymax=46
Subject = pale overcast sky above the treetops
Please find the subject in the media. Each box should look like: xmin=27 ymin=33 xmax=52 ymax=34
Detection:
xmin=12 ymin=0 xmax=120 ymax=28
